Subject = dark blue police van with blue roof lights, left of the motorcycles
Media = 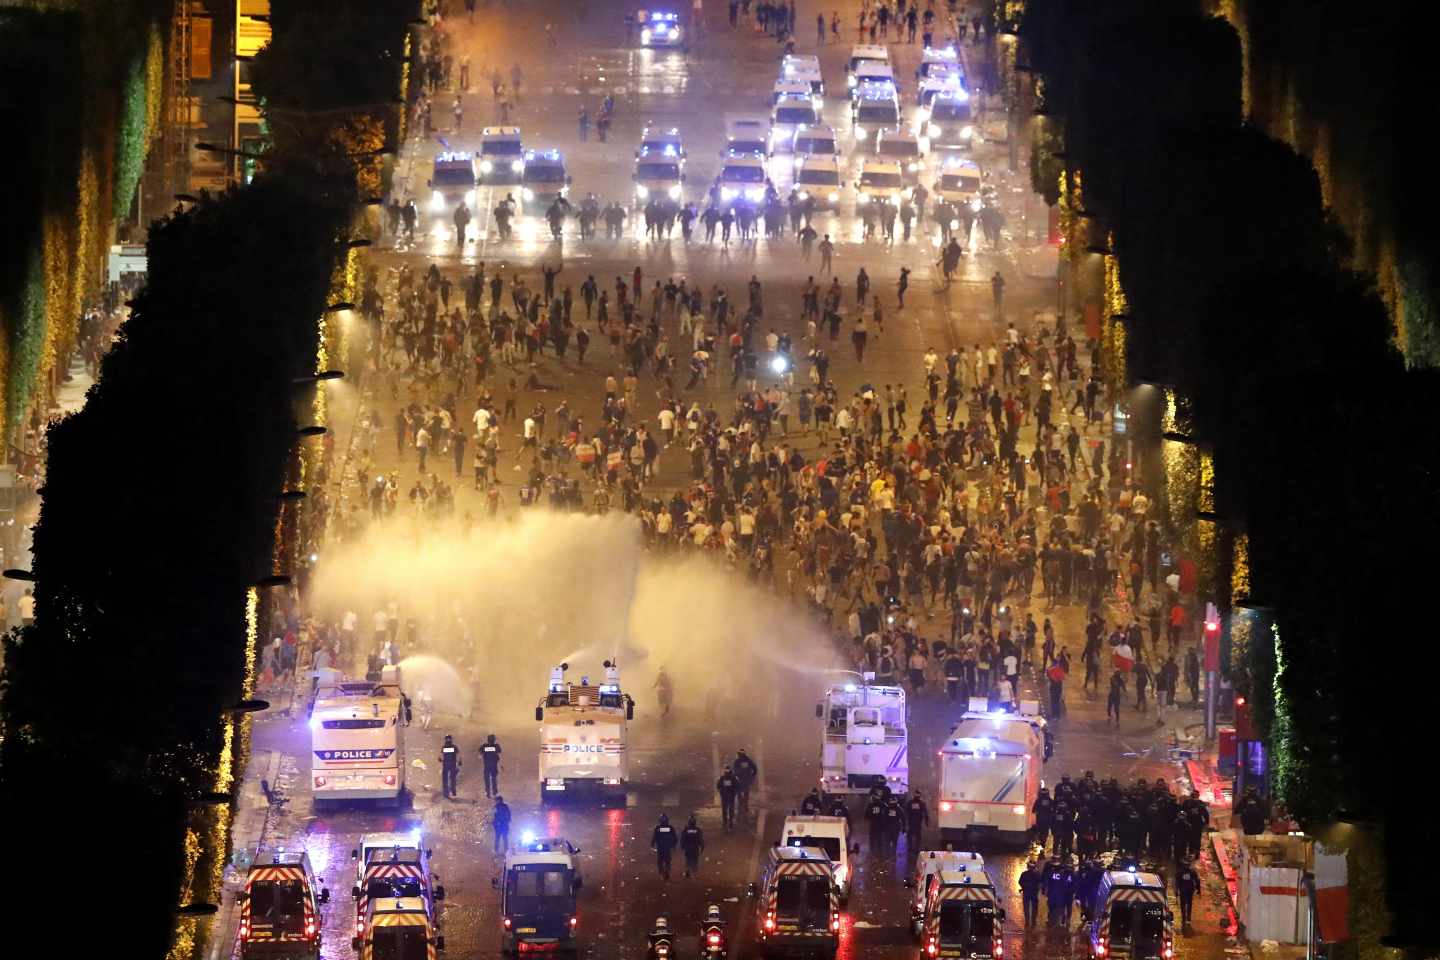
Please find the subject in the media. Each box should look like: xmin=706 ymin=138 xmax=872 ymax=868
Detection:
xmin=491 ymin=835 xmax=583 ymax=954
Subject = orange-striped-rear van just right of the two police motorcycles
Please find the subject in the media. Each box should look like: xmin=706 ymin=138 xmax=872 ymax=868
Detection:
xmin=750 ymin=845 xmax=840 ymax=957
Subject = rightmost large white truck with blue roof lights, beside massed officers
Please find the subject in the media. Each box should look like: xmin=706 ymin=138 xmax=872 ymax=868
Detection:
xmin=939 ymin=711 xmax=1050 ymax=846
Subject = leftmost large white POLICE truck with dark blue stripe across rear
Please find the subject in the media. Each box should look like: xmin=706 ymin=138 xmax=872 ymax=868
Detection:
xmin=310 ymin=666 xmax=405 ymax=813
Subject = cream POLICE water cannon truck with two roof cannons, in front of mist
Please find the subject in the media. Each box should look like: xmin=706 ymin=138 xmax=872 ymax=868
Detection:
xmin=536 ymin=661 xmax=635 ymax=805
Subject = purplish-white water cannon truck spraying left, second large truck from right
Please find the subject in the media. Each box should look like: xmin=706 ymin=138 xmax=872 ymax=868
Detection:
xmin=815 ymin=674 xmax=910 ymax=794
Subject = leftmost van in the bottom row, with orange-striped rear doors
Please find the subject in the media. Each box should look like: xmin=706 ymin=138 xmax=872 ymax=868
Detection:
xmin=236 ymin=846 xmax=330 ymax=960
